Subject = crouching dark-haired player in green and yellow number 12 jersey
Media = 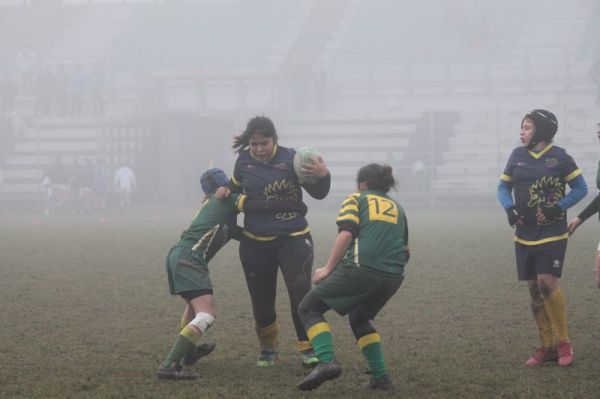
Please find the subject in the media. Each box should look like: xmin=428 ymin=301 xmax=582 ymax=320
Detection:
xmin=298 ymin=164 xmax=410 ymax=391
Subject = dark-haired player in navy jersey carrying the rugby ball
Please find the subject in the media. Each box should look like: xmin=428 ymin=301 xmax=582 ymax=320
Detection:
xmin=230 ymin=116 xmax=331 ymax=367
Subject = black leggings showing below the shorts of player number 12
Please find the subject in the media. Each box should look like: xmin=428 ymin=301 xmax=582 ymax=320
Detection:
xmin=298 ymin=291 xmax=377 ymax=341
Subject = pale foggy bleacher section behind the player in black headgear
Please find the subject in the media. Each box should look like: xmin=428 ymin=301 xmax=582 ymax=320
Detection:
xmin=432 ymin=108 xmax=599 ymax=198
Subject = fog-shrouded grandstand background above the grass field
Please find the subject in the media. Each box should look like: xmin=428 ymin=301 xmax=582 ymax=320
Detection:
xmin=0 ymin=0 xmax=600 ymax=208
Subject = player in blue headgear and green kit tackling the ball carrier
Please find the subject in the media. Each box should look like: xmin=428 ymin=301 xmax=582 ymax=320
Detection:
xmin=156 ymin=169 xmax=306 ymax=380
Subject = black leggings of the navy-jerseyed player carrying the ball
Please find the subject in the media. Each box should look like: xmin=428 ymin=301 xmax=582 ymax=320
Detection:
xmin=240 ymin=234 xmax=313 ymax=341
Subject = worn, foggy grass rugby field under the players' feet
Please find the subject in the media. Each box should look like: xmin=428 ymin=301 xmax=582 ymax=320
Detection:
xmin=0 ymin=206 xmax=600 ymax=398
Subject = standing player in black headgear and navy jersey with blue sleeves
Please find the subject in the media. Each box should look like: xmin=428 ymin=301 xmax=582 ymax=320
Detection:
xmin=497 ymin=109 xmax=587 ymax=366
